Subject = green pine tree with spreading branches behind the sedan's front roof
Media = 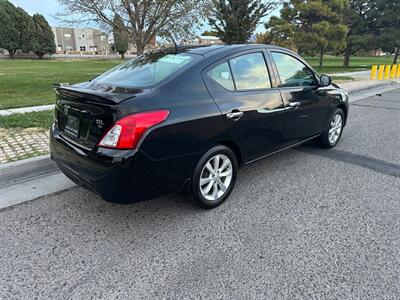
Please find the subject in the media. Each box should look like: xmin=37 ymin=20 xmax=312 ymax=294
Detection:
xmin=265 ymin=0 xmax=348 ymax=67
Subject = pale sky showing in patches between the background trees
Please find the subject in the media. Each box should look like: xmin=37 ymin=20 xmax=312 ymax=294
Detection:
xmin=10 ymin=0 xmax=279 ymax=32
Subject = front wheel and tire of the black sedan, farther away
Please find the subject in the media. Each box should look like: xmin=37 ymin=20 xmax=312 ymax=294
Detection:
xmin=319 ymin=108 xmax=345 ymax=149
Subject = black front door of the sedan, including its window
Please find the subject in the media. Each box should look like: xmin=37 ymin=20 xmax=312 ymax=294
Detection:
xmin=269 ymin=50 xmax=334 ymax=143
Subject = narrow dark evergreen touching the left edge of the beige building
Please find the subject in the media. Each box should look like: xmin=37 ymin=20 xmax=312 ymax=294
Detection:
xmin=32 ymin=14 xmax=56 ymax=58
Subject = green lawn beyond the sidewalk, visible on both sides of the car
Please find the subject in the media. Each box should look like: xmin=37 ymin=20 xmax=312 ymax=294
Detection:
xmin=0 ymin=56 xmax=392 ymax=109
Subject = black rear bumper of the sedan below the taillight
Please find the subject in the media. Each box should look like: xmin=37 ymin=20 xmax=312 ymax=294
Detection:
xmin=50 ymin=127 xmax=189 ymax=203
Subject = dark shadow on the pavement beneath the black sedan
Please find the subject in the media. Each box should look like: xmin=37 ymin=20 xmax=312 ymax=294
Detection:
xmin=18 ymin=151 xmax=304 ymax=227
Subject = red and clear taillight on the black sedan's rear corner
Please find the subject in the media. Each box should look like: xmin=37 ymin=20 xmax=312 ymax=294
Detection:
xmin=98 ymin=110 xmax=169 ymax=149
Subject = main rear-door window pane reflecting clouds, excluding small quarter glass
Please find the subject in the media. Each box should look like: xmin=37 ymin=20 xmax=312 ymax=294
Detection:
xmin=230 ymin=53 xmax=271 ymax=90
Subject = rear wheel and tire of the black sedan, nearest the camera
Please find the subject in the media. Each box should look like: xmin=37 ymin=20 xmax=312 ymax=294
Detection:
xmin=191 ymin=145 xmax=238 ymax=209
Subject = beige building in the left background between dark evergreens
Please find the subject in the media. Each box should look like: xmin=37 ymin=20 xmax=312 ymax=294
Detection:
xmin=52 ymin=27 xmax=110 ymax=54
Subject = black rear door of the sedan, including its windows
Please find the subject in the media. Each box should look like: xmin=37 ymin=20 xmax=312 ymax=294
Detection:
xmin=203 ymin=49 xmax=285 ymax=162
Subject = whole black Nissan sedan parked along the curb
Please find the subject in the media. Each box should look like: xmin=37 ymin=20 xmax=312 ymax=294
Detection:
xmin=51 ymin=45 xmax=349 ymax=208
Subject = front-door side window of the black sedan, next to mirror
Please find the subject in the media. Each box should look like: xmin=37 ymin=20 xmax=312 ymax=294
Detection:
xmin=272 ymin=52 xmax=317 ymax=87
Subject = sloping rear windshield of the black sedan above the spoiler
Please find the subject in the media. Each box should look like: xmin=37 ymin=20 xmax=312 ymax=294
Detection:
xmin=92 ymin=52 xmax=196 ymax=88
